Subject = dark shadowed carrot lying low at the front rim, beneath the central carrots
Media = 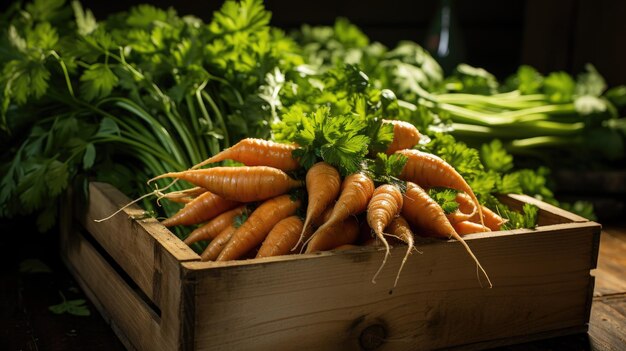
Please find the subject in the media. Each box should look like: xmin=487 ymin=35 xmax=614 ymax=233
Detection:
xmin=305 ymin=216 xmax=359 ymax=253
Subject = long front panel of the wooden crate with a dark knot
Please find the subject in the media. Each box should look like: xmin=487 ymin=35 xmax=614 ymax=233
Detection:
xmin=189 ymin=225 xmax=597 ymax=350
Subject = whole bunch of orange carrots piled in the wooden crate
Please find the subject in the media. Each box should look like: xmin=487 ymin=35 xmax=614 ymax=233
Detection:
xmin=152 ymin=121 xmax=504 ymax=288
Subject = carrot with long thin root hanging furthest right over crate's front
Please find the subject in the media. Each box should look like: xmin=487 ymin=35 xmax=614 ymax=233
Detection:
xmin=402 ymin=182 xmax=492 ymax=287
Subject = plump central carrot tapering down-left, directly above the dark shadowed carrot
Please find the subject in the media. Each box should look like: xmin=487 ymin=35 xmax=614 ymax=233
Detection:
xmin=312 ymin=173 xmax=374 ymax=245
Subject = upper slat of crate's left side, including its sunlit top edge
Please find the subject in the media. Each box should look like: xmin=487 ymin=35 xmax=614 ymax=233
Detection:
xmin=79 ymin=183 xmax=200 ymax=307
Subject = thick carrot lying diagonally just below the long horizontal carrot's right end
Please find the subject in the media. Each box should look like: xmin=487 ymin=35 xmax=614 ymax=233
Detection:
xmin=217 ymin=195 xmax=300 ymax=261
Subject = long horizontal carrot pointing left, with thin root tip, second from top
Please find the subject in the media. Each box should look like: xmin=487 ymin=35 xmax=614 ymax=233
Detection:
xmin=150 ymin=166 xmax=302 ymax=202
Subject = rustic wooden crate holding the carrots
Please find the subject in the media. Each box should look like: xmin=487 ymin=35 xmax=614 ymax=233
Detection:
xmin=61 ymin=183 xmax=601 ymax=350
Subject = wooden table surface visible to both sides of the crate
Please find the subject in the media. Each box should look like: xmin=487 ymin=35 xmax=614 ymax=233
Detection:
xmin=0 ymin=220 xmax=626 ymax=351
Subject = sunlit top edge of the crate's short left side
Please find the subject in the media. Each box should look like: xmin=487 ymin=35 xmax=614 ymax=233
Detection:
xmin=85 ymin=182 xmax=200 ymax=261
